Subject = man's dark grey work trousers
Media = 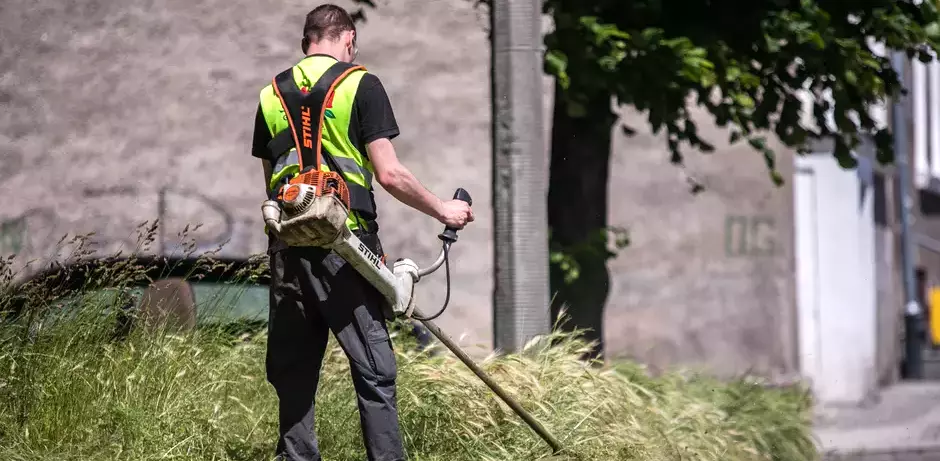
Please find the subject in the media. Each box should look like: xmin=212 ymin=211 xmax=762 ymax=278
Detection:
xmin=266 ymin=234 xmax=405 ymax=461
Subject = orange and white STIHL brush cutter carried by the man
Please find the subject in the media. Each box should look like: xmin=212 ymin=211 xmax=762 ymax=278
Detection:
xmin=262 ymin=182 xmax=562 ymax=454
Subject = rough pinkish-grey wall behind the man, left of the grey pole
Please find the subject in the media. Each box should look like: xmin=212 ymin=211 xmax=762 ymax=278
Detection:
xmin=0 ymin=0 xmax=500 ymax=352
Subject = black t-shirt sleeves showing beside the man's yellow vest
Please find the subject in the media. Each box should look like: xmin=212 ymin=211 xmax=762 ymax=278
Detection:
xmin=251 ymin=73 xmax=399 ymax=164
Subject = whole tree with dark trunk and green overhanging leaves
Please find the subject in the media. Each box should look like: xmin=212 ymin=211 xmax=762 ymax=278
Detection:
xmin=352 ymin=0 xmax=940 ymax=360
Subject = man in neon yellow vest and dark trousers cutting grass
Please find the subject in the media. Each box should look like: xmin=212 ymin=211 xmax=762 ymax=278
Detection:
xmin=252 ymin=4 xmax=473 ymax=461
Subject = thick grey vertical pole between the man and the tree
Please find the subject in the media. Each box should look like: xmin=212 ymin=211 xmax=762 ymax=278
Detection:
xmin=490 ymin=0 xmax=551 ymax=352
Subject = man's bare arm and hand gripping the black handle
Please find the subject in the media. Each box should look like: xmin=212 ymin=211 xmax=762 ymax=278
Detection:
xmin=366 ymin=138 xmax=473 ymax=229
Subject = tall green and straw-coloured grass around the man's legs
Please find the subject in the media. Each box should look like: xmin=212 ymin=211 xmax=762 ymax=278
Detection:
xmin=0 ymin=226 xmax=817 ymax=461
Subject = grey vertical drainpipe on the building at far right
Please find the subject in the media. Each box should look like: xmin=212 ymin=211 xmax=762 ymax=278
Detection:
xmin=891 ymin=51 xmax=924 ymax=379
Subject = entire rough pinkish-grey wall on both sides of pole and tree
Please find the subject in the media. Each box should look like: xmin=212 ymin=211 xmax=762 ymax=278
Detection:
xmin=0 ymin=0 xmax=796 ymax=375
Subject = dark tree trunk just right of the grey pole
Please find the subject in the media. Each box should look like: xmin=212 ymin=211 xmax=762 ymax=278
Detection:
xmin=548 ymin=83 xmax=616 ymax=359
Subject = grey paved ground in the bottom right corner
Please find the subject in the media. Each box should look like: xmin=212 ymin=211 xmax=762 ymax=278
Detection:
xmin=816 ymin=380 xmax=940 ymax=461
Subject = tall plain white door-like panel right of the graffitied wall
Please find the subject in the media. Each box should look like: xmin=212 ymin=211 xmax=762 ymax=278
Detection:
xmin=794 ymin=153 xmax=877 ymax=403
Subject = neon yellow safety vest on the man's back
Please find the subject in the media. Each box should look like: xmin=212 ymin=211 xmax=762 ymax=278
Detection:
xmin=261 ymin=56 xmax=375 ymax=229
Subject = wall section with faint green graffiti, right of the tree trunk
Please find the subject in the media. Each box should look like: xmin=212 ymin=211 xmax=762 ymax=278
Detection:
xmin=605 ymin=105 xmax=796 ymax=376
